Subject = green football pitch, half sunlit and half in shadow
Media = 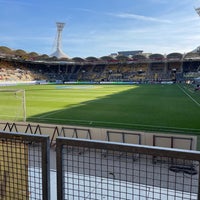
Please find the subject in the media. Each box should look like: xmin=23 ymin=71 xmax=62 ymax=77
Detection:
xmin=0 ymin=84 xmax=200 ymax=134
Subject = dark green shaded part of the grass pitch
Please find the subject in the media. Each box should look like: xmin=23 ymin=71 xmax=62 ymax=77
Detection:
xmin=27 ymin=85 xmax=200 ymax=134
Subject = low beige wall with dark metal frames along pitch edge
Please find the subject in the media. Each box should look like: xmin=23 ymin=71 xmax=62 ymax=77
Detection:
xmin=0 ymin=122 xmax=198 ymax=150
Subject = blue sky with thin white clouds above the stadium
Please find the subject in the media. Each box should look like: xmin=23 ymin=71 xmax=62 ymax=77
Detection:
xmin=0 ymin=0 xmax=200 ymax=58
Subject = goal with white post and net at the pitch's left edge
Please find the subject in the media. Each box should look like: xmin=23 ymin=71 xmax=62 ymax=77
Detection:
xmin=0 ymin=89 xmax=26 ymax=121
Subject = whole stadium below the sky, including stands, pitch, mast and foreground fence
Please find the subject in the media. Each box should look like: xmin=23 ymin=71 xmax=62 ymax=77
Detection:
xmin=0 ymin=23 xmax=200 ymax=200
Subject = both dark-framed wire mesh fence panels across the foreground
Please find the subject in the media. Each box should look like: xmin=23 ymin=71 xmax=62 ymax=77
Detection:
xmin=0 ymin=129 xmax=200 ymax=200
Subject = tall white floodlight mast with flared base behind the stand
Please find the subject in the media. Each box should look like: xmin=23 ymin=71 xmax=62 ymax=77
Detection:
xmin=51 ymin=22 xmax=68 ymax=58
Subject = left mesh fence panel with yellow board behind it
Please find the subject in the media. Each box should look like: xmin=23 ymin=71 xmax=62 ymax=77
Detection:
xmin=0 ymin=131 xmax=50 ymax=200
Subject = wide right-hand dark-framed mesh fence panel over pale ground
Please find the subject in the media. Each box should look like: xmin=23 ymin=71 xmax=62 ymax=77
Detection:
xmin=56 ymin=137 xmax=200 ymax=200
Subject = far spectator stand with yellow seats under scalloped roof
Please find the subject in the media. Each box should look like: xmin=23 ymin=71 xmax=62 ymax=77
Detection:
xmin=0 ymin=50 xmax=200 ymax=83
